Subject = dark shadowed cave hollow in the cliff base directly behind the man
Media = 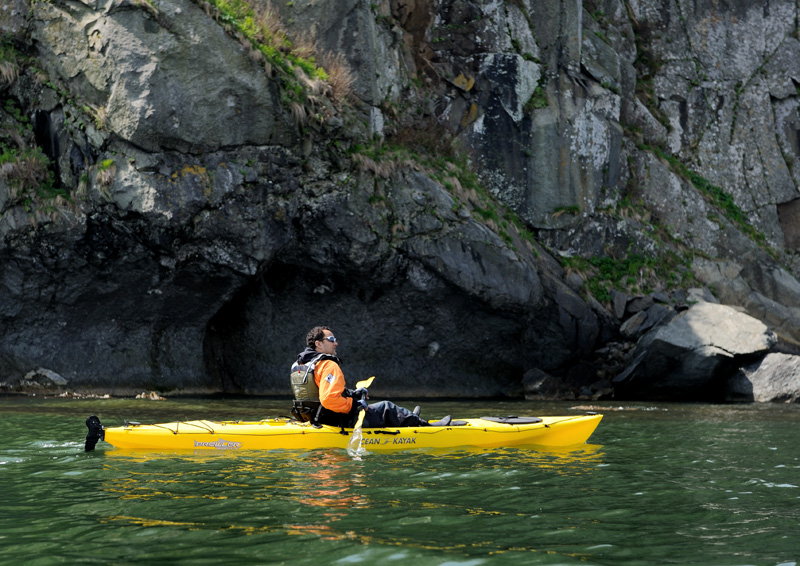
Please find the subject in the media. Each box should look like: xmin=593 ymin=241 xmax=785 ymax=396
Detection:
xmin=204 ymin=261 xmax=524 ymax=397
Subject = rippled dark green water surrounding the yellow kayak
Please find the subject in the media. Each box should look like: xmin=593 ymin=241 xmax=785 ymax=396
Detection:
xmin=0 ymin=398 xmax=800 ymax=566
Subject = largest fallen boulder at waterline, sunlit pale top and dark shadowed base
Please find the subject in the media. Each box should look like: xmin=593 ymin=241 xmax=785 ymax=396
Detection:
xmin=614 ymin=302 xmax=777 ymax=400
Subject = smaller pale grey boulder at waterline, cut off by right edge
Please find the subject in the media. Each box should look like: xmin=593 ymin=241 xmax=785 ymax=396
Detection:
xmin=725 ymin=353 xmax=800 ymax=403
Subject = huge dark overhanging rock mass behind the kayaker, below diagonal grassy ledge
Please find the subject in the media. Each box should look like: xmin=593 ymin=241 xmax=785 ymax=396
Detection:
xmin=0 ymin=2 xmax=612 ymax=396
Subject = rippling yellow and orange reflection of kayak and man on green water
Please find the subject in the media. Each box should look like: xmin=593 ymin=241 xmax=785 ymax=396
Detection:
xmin=95 ymin=445 xmax=604 ymax=554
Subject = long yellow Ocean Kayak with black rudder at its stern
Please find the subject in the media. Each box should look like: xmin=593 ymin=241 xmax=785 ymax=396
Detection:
xmin=86 ymin=414 xmax=603 ymax=451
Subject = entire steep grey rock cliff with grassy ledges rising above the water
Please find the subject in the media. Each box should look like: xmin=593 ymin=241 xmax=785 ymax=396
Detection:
xmin=0 ymin=0 xmax=800 ymax=397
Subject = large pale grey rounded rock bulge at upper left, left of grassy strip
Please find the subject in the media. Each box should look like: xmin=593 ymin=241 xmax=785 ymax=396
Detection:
xmin=32 ymin=0 xmax=292 ymax=154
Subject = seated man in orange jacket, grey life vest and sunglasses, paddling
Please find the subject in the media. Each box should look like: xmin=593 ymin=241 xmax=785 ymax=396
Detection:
xmin=291 ymin=326 xmax=450 ymax=428
